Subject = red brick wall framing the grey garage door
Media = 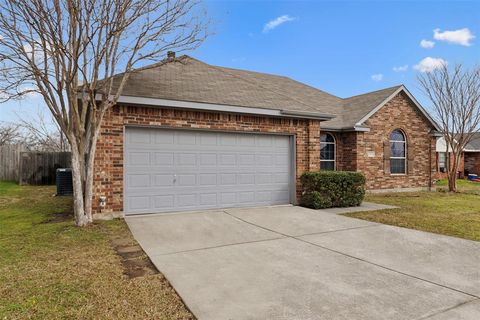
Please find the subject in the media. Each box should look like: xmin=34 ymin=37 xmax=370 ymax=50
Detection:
xmin=93 ymin=106 xmax=320 ymax=213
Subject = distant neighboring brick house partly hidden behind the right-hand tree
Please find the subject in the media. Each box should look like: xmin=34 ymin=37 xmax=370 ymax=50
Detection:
xmin=436 ymin=132 xmax=480 ymax=179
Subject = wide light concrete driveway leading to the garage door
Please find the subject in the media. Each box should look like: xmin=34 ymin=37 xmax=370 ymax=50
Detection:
xmin=126 ymin=206 xmax=480 ymax=320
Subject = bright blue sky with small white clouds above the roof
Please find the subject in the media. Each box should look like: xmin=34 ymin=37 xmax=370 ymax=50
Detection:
xmin=0 ymin=1 xmax=480 ymax=121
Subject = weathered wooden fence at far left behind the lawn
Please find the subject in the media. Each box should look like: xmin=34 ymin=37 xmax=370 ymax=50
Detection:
xmin=0 ymin=146 xmax=71 ymax=185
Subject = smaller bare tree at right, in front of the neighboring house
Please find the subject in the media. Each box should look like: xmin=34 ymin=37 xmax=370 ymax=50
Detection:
xmin=418 ymin=64 xmax=480 ymax=192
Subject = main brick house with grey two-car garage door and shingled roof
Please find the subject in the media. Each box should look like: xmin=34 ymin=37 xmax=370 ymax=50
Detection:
xmin=93 ymin=56 xmax=438 ymax=218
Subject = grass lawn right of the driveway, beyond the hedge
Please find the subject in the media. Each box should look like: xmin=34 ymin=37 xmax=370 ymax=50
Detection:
xmin=346 ymin=185 xmax=480 ymax=241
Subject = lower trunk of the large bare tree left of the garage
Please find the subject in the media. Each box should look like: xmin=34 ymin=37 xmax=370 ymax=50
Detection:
xmin=71 ymin=145 xmax=89 ymax=227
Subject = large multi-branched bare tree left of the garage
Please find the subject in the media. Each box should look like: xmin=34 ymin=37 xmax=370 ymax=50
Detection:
xmin=0 ymin=0 xmax=207 ymax=226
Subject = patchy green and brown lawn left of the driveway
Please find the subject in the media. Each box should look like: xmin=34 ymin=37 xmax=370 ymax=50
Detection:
xmin=0 ymin=182 xmax=193 ymax=319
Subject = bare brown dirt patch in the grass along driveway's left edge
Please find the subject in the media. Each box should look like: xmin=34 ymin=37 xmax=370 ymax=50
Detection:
xmin=112 ymin=239 xmax=159 ymax=279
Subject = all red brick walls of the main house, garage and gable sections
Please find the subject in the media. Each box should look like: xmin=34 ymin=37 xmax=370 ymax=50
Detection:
xmin=93 ymin=93 xmax=436 ymax=213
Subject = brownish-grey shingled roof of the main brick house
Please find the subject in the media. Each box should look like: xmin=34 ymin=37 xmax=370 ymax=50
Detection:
xmin=109 ymin=55 xmax=434 ymax=130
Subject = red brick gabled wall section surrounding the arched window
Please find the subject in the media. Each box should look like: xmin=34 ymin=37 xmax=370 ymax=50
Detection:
xmin=322 ymin=93 xmax=436 ymax=190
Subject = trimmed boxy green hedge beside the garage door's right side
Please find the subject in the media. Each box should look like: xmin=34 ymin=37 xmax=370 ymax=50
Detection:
xmin=300 ymin=171 xmax=365 ymax=209
